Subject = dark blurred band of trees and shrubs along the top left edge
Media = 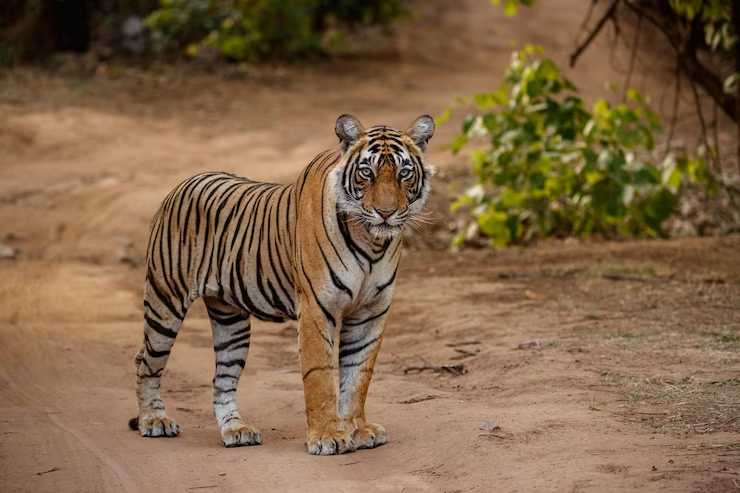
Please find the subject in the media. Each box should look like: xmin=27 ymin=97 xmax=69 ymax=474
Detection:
xmin=0 ymin=0 xmax=407 ymax=64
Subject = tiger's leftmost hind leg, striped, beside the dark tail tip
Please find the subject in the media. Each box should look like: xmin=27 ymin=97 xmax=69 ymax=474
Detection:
xmin=129 ymin=286 xmax=184 ymax=437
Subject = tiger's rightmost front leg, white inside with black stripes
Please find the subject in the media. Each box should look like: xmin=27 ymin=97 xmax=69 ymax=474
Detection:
xmin=338 ymin=308 xmax=388 ymax=449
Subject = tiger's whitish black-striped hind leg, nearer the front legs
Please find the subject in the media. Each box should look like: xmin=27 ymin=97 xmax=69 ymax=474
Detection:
xmin=204 ymin=298 xmax=262 ymax=447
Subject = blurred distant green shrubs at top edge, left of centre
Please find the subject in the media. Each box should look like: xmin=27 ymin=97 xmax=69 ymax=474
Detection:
xmin=146 ymin=0 xmax=405 ymax=61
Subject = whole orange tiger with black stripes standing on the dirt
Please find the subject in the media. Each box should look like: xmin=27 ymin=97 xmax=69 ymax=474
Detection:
xmin=129 ymin=115 xmax=435 ymax=455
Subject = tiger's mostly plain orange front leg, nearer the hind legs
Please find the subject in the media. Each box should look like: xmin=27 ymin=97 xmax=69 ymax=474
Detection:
xmin=298 ymin=303 xmax=355 ymax=455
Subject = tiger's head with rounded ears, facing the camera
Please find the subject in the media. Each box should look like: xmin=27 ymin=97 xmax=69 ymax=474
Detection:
xmin=336 ymin=115 xmax=434 ymax=238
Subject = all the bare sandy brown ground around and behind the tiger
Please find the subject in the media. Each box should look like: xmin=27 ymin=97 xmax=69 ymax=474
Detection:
xmin=0 ymin=0 xmax=740 ymax=492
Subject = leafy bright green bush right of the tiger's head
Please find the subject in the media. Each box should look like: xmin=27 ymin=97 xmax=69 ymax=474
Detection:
xmin=452 ymin=46 xmax=711 ymax=246
